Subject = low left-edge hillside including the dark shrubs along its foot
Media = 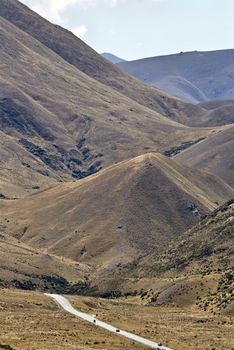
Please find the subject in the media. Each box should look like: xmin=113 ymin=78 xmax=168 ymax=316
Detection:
xmin=0 ymin=230 xmax=89 ymax=292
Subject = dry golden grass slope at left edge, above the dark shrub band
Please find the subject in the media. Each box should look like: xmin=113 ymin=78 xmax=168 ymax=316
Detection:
xmin=0 ymin=230 xmax=89 ymax=285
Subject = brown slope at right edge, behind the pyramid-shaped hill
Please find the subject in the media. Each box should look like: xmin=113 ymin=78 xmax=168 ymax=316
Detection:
xmin=175 ymin=126 xmax=234 ymax=187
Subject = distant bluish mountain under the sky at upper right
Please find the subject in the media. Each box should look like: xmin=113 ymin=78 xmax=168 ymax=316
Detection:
xmin=119 ymin=50 xmax=234 ymax=103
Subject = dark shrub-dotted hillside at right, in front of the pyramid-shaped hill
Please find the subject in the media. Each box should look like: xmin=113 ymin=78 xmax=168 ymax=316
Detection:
xmin=149 ymin=200 xmax=234 ymax=276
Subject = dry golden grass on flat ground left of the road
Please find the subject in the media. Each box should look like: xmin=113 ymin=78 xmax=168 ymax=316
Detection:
xmin=0 ymin=290 xmax=144 ymax=350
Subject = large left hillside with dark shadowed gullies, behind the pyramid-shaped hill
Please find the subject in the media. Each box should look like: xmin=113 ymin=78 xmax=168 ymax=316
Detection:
xmin=0 ymin=10 xmax=218 ymax=198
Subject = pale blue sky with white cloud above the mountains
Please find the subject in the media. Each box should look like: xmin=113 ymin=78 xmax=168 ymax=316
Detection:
xmin=21 ymin=0 xmax=234 ymax=60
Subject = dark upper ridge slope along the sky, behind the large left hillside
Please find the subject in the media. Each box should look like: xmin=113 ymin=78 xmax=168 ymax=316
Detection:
xmin=0 ymin=0 xmax=208 ymax=122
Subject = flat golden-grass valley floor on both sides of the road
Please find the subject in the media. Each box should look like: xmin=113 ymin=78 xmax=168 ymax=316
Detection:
xmin=0 ymin=289 xmax=234 ymax=350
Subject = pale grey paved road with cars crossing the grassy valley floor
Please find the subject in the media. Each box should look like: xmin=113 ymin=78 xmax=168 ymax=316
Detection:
xmin=45 ymin=293 xmax=172 ymax=350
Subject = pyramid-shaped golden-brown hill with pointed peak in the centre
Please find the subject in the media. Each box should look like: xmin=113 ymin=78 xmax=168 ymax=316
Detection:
xmin=0 ymin=154 xmax=233 ymax=284
